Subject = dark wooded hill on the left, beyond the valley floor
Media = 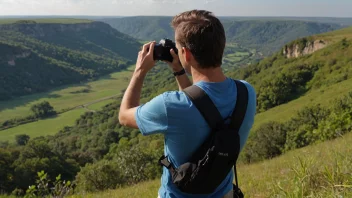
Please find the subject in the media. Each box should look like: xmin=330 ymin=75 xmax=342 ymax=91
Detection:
xmin=0 ymin=19 xmax=140 ymax=100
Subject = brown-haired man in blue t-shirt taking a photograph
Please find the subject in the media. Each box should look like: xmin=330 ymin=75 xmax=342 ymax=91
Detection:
xmin=119 ymin=10 xmax=256 ymax=198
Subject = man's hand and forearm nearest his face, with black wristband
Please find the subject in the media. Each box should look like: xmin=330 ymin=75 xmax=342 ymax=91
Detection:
xmin=165 ymin=49 xmax=192 ymax=91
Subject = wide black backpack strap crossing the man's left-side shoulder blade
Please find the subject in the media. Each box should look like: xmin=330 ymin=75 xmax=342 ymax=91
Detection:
xmin=183 ymin=85 xmax=223 ymax=129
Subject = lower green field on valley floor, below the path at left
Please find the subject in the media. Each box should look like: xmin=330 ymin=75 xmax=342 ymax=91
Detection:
xmin=0 ymin=109 xmax=86 ymax=142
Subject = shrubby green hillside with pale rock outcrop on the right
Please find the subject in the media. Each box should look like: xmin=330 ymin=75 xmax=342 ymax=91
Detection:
xmin=230 ymin=28 xmax=352 ymax=111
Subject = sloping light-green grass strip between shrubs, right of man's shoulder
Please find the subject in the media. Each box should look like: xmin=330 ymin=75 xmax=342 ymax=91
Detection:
xmin=253 ymin=79 xmax=352 ymax=130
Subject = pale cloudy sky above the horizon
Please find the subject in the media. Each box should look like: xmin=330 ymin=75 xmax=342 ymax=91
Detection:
xmin=0 ymin=0 xmax=352 ymax=17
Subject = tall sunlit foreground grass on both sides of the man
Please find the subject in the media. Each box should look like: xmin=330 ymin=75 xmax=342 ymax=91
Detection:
xmin=71 ymin=133 xmax=352 ymax=198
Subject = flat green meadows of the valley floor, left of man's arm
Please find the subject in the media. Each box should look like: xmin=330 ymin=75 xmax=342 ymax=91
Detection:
xmin=0 ymin=66 xmax=134 ymax=142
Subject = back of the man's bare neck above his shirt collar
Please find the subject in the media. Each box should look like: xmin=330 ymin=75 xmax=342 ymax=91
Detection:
xmin=191 ymin=64 xmax=226 ymax=84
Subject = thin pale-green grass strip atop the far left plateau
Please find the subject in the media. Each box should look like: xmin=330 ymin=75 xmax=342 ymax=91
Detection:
xmin=0 ymin=18 xmax=93 ymax=25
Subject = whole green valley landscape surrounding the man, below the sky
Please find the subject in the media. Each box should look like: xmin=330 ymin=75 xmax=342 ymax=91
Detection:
xmin=0 ymin=17 xmax=352 ymax=198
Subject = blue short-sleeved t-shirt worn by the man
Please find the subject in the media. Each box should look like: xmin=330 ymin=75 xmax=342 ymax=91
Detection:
xmin=135 ymin=78 xmax=256 ymax=198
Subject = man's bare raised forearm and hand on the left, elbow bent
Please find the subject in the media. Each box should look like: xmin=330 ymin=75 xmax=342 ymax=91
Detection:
xmin=119 ymin=42 xmax=155 ymax=129
